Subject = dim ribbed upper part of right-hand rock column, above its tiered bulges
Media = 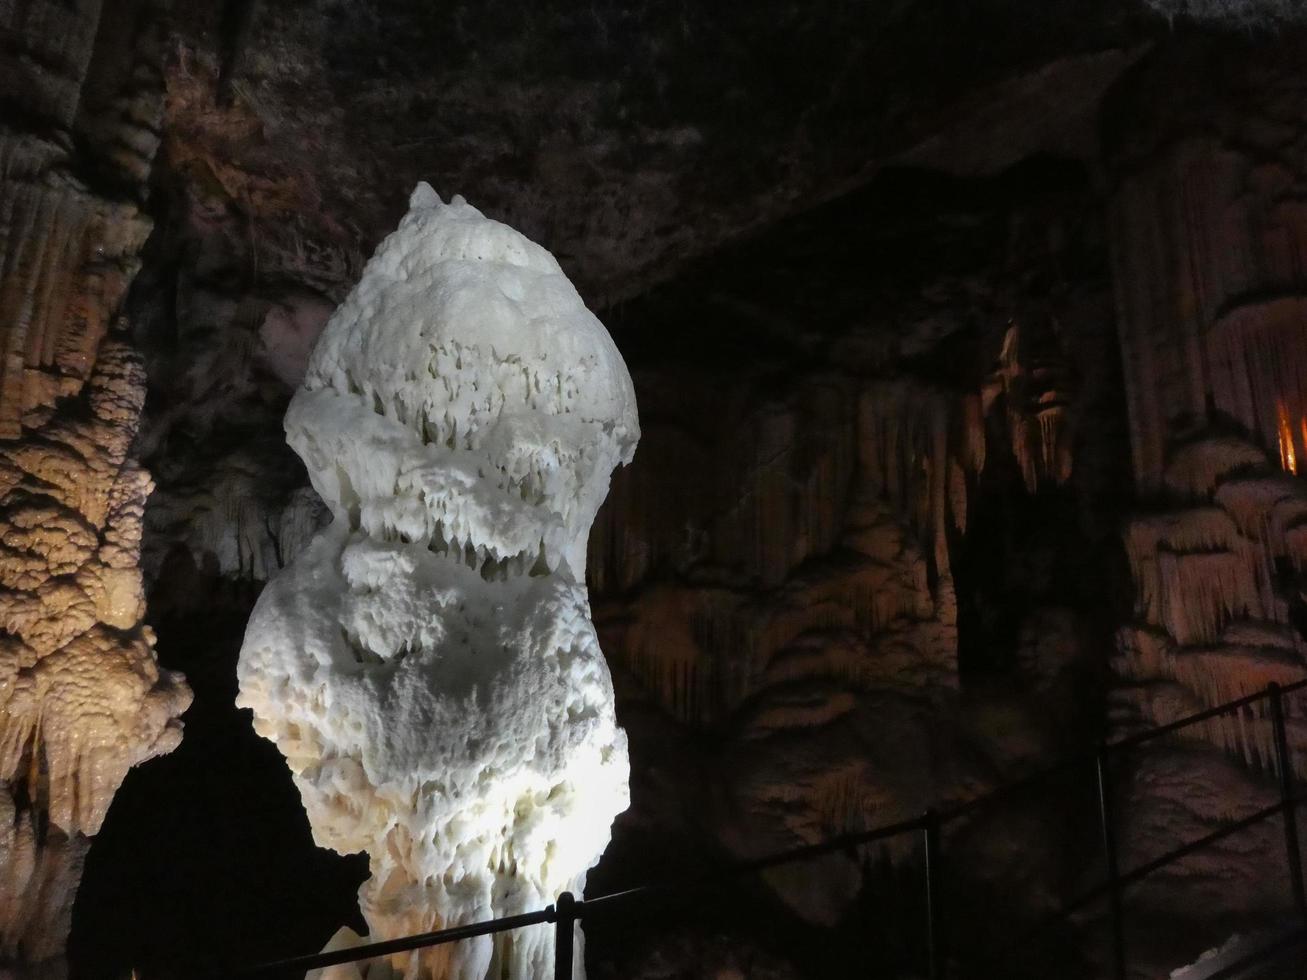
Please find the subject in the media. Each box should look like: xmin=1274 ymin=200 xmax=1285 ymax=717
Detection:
xmin=1104 ymin=31 xmax=1307 ymax=494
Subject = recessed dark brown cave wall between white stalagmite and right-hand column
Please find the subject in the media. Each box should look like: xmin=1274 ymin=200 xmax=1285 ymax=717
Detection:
xmin=577 ymin=161 xmax=1128 ymax=966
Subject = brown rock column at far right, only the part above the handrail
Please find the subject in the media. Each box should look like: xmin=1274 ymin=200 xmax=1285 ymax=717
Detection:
xmin=1112 ymin=35 xmax=1307 ymax=759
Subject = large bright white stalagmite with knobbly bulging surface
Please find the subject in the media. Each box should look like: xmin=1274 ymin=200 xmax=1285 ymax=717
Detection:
xmin=238 ymin=184 xmax=639 ymax=980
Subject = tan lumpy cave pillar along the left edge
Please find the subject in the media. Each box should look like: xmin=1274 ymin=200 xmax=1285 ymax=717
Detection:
xmin=0 ymin=0 xmax=190 ymax=976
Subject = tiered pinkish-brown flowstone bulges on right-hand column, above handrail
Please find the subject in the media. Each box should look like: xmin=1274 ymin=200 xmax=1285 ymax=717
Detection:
xmin=1117 ymin=436 xmax=1307 ymax=766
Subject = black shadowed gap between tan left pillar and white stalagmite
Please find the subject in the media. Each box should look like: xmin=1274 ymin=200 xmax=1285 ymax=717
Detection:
xmin=69 ymin=580 xmax=367 ymax=980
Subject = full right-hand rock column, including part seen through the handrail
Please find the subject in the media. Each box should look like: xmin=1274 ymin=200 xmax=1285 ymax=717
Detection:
xmin=1104 ymin=31 xmax=1307 ymax=935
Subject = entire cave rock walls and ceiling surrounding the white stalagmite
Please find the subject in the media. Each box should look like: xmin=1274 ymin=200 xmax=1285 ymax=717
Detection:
xmin=0 ymin=0 xmax=1307 ymax=980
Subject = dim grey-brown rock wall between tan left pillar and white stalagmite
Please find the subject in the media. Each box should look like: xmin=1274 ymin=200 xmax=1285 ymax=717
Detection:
xmin=132 ymin=55 xmax=352 ymax=605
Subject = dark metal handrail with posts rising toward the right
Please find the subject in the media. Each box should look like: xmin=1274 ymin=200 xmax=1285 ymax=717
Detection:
xmin=237 ymin=678 xmax=1307 ymax=980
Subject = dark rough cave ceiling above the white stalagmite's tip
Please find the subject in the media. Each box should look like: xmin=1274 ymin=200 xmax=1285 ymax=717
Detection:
xmin=171 ymin=0 xmax=1167 ymax=307
